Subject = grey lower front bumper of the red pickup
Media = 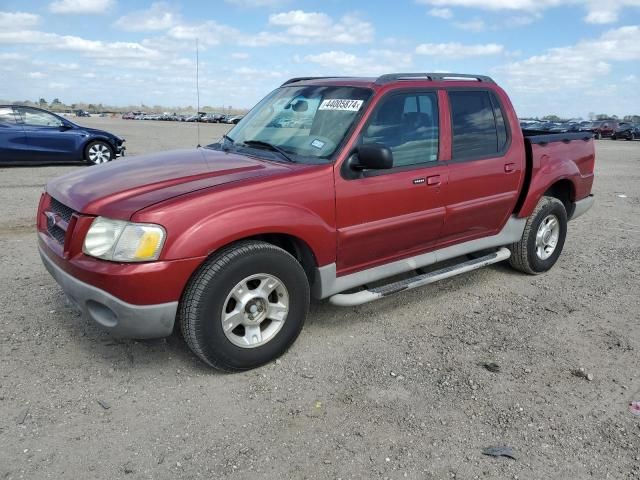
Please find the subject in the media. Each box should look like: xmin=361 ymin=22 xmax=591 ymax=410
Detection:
xmin=39 ymin=248 xmax=178 ymax=339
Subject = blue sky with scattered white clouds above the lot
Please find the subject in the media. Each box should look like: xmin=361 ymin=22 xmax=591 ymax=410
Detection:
xmin=0 ymin=0 xmax=640 ymax=117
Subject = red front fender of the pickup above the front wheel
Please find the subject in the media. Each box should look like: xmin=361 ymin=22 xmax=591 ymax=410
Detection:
xmin=132 ymin=164 xmax=336 ymax=265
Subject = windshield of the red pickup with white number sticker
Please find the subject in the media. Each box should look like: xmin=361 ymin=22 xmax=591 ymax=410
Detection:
xmin=209 ymin=85 xmax=371 ymax=163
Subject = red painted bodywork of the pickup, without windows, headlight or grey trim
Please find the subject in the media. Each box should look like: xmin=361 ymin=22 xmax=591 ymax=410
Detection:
xmin=37 ymin=79 xmax=595 ymax=305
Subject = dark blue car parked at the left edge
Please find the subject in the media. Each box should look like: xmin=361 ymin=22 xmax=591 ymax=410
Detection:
xmin=0 ymin=105 xmax=125 ymax=165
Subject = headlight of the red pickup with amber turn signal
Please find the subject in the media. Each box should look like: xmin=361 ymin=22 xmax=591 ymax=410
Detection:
xmin=82 ymin=217 xmax=167 ymax=262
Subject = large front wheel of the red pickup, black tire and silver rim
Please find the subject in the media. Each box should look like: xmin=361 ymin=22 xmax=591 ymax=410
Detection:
xmin=178 ymin=241 xmax=310 ymax=372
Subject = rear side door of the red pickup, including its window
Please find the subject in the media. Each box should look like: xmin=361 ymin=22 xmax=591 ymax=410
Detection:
xmin=442 ymin=89 xmax=524 ymax=243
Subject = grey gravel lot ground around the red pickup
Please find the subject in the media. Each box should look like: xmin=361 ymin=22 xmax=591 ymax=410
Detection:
xmin=0 ymin=118 xmax=640 ymax=479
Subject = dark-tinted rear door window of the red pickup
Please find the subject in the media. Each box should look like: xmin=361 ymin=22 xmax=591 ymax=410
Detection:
xmin=449 ymin=90 xmax=508 ymax=160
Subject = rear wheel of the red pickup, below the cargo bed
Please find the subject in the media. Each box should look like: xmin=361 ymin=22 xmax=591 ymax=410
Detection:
xmin=509 ymin=197 xmax=567 ymax=275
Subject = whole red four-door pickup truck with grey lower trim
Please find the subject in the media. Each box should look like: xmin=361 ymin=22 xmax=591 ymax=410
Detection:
xmin=37 ymin=73 xmax=595 ymax=371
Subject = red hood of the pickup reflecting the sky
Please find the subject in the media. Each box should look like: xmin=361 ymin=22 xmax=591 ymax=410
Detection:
xmin=46 ymin=148 xmax=288 ymax=219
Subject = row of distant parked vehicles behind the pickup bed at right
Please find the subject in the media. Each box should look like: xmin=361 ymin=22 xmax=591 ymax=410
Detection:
xmin=520 ymin=120 xmax=640 ymax=140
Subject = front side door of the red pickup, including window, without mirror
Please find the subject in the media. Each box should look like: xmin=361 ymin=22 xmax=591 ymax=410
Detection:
xmin=335 ymin=90 xmax=448 ymax=276
